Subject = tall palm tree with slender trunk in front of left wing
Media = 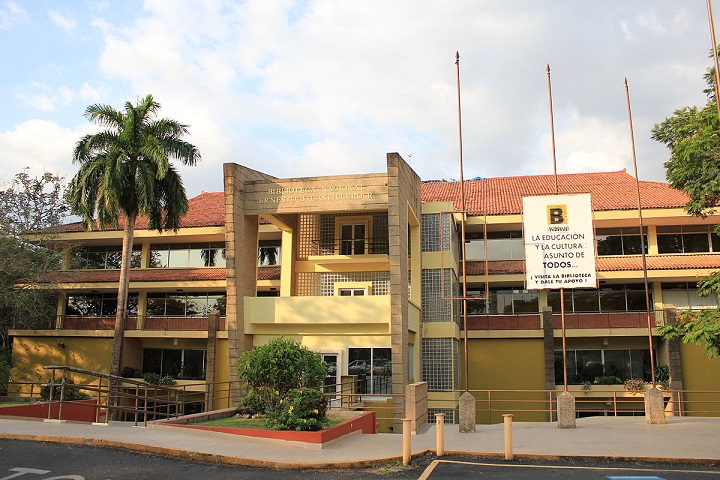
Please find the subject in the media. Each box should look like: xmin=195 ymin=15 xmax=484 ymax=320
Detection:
xmin=68 ymin=95 xmax=200 ymax=375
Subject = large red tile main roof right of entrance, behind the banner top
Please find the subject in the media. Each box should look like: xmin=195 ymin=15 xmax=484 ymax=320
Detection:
xmin=422 ymin=170 xmax=688 ymax=215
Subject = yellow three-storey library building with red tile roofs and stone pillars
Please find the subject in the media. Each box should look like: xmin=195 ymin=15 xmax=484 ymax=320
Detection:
xmin=11 ymin=154 xmax=720 ymax=421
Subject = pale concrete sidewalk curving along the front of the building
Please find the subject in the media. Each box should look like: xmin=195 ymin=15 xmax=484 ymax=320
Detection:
xmin=0 ymin=417 xmax=720 ymax=468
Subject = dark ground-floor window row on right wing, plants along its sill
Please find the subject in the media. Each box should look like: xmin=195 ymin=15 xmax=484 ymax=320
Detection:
xmin=555 ymin=349 xmax=650 ymax=385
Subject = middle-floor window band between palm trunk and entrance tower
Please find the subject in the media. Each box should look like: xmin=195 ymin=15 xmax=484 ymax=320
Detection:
xmin=146 ymin=292 xmax=226 ymax=317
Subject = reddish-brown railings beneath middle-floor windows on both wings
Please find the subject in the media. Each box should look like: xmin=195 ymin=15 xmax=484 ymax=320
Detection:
xmin=48 ymin=310 xmax=666 ymax=331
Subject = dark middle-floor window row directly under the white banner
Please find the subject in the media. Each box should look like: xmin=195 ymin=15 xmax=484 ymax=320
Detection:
xmin=548 ymin=284 xmax=653 ymax=313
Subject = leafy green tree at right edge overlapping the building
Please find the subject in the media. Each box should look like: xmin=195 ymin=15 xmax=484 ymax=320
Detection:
xmin=652 ymin=55 xmax=720 ymax=358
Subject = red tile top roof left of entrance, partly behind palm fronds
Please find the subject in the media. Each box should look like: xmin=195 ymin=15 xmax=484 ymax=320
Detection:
xmin=49 ymin=192 xmax=225 ymax=233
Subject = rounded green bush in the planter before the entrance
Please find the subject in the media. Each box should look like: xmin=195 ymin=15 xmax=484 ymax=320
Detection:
xmin=235 ymin=337 xmax=327 ymax=415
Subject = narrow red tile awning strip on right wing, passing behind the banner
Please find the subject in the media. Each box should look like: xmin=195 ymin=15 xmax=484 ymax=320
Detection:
xmin=467 ymin=254 xmax=720 ymax=275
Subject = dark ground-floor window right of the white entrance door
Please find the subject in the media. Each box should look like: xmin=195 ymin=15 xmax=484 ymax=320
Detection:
xmin=348 ymin=348 xmax=392 ymax=393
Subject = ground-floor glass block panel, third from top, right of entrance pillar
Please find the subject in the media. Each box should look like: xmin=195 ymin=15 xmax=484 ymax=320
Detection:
xmin=422 ymin=338 xmax=460 ymax=390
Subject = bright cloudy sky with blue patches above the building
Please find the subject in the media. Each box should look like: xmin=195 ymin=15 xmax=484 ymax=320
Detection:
xmin=0 ymin=0 xmax=720 ymax=196
